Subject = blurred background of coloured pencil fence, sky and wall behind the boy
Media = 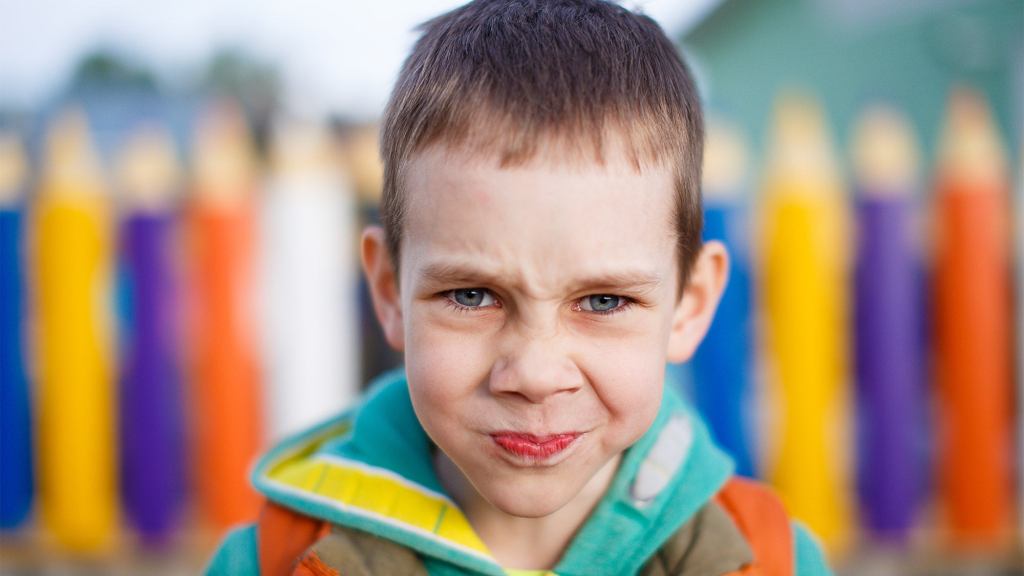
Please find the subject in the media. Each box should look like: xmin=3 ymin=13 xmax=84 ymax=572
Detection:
xmin=0 ymin=0 xmax=1024 ymax=575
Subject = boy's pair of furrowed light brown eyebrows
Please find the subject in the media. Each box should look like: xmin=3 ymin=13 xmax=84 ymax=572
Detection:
xmin=420 ymin=262 xmax=662 ymax=293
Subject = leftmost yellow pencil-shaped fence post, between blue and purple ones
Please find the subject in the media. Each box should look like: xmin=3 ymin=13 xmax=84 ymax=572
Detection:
xmin=35 ymin=109 xmax=117 ymax=552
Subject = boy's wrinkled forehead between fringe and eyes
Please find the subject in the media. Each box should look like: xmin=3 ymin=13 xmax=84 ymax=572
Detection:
xmin=401 ymin=147 xmax=676 ymax=290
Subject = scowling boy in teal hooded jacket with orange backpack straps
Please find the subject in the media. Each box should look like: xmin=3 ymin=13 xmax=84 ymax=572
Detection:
xmin=209 ymin=0 xmax=827 ymax=576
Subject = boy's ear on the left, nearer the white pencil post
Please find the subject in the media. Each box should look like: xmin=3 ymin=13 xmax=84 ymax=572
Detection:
xmin=361 ymin=227 xmax=406 ymax=352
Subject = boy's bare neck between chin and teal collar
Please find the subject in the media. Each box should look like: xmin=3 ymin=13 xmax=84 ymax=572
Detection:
xmin=434 ymin=450 xmax=621 ymax=570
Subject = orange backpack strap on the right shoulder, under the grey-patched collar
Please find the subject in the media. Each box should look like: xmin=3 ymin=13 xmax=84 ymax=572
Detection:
xmin=715 ymin=477 xmax=795 ymax=576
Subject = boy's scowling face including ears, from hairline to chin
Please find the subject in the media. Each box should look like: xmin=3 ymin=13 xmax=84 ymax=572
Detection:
xmin=364 ymin=142 xmax=726 ymax=517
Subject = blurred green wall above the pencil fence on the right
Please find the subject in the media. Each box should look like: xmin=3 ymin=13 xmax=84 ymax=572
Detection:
xmin=682 ymin=0 xmax=1024 ymax=177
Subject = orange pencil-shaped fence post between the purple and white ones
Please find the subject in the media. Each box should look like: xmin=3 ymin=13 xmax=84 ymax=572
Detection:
xmin=187 ymin=107 xmax=263 ymax=529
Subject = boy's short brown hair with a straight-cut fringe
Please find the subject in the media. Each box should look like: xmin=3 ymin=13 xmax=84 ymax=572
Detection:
xmin=381 ymin=0 xmax=703 ymax=288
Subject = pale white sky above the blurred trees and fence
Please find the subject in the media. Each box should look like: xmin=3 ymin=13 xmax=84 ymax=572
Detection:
xmin=0 ymin=0 xmax=718 ymax=118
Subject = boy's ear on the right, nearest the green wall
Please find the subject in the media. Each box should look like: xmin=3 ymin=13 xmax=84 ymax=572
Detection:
xmin=668 ymin=241 xmax=729 ymax=363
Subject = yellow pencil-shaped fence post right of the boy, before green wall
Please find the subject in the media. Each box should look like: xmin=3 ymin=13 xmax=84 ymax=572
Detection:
xmin=761 ymin=90 xmax=850 ymax=551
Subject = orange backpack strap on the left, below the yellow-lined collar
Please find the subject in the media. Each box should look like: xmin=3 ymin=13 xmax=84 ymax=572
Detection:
xmin=256 ymin=501 xmax=331 ymax=576
